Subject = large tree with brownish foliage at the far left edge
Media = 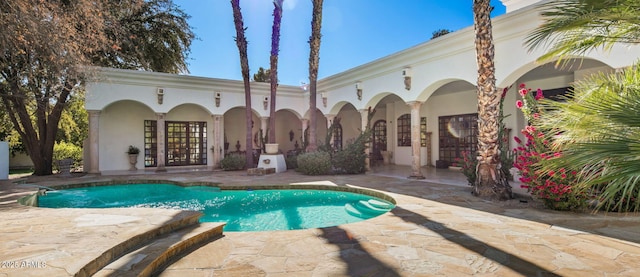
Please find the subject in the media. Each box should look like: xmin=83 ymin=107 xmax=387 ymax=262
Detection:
xmin=0 ymin=0 xmax=192 ymax=175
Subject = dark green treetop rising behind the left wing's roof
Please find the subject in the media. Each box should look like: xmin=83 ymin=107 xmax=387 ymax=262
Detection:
xmin=92 ymin=0 xmax=195 ymax=73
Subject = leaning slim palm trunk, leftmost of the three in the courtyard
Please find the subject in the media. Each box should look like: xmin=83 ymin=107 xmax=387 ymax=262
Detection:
xmin=231 ymin=0 xmax=253 ymax=167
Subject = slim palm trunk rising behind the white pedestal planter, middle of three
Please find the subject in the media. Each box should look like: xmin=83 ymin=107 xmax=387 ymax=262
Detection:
xmin=269 ymin=0 xmax=284 ymax=143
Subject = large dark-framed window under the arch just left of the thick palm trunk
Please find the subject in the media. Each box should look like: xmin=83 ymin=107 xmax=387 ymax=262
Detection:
xmin=438 ymin=113 xmax=478 ymax=164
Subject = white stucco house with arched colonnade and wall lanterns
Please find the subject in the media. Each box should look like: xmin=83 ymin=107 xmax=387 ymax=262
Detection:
xmin=84 ymin=0 xmax=640 ymax=177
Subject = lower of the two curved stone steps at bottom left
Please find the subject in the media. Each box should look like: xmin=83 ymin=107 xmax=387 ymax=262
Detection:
xmin=93 ymin=223 xmax=224 ymax=276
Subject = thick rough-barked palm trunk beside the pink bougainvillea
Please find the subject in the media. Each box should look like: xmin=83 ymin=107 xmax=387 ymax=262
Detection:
xmin=473 ymin=0 xmax=512 ymax=200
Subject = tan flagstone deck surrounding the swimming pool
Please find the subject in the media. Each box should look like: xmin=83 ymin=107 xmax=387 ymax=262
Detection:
xmin=0 ymin=166 xmax=640 ymax=276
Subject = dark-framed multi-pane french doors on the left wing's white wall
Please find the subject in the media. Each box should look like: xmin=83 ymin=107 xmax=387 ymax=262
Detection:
xmin=165 ymin=121 xmax=207 ymax=166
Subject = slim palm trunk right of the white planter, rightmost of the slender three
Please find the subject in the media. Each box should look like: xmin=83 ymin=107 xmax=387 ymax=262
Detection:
xmin=307 ymin=0 xmax=323 ymax=152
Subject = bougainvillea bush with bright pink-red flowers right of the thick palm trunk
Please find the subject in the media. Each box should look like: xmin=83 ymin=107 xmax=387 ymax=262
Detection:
xmin=514 ymin=84 xmax=588 ymax=210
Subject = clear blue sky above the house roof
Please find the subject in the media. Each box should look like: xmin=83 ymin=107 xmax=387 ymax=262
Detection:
xmin=174 ymin=0 xmax=505 ymax=85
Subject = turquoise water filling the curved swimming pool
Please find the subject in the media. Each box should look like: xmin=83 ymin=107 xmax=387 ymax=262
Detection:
xmin=38 ymin=184 xmax=393 ymax=231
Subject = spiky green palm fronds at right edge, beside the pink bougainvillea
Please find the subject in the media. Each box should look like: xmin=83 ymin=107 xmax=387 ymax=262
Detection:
xmin=539 ymin=64 xmax=640 ymax=211
